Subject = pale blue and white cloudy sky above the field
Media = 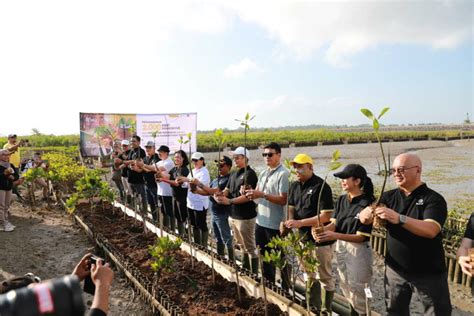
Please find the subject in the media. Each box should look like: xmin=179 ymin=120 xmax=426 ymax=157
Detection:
xmin=0 ymin=0 xmax=474 ymax=135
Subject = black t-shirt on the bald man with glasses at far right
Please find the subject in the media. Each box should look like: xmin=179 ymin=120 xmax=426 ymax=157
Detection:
xmin=380 ymin=184 xmax=448 ymax=275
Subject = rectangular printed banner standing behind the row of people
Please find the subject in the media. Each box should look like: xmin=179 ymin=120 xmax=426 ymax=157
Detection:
xmin=79 ymin=113 xmax=197 ymax=159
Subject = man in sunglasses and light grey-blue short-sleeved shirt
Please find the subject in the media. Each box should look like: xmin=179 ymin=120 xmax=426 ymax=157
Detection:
xmin=245 ymin=142 xmax=290 ymax=288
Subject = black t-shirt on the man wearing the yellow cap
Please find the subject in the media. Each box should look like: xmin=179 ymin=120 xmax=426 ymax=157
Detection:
xmin=288 ymin=174 xmax=335 ymax=246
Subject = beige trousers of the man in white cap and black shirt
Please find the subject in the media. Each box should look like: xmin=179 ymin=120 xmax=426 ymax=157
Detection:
xmin=229 ymin=217 xmax=258 ymax=258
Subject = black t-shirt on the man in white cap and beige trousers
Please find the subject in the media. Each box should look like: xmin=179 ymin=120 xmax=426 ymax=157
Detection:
xmin=227 ymin=166 xmax=258 ymax=219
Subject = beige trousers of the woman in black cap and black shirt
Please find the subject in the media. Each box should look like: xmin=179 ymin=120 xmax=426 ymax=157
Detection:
xmin=336 ymin=240 xmax=372 ymax=314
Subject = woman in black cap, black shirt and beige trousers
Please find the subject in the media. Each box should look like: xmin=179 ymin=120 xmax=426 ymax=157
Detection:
xmin=314 ymin=164 xmax=375 ymax=315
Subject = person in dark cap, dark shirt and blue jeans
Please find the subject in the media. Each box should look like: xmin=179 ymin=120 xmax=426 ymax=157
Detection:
xmin=194 ymin=156 xmax=234 ymax=261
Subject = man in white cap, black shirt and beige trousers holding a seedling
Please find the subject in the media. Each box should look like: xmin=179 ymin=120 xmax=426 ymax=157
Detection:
xmin=214 ymin=147 xmax=258 ymax=273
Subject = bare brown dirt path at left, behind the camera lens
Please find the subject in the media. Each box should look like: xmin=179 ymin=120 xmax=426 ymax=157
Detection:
xmin=0 ymin=202 xmax=151 ymax=315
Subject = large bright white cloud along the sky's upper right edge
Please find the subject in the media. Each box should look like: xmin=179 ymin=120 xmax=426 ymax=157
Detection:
xmin=220 ymin=0 xmax=473 ymax=67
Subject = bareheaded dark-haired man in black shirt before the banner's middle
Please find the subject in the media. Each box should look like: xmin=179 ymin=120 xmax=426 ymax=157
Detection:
xmin=124 ymin=135 xmax=148 ymax=215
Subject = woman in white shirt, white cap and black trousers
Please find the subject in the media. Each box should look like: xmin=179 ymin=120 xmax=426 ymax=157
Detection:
xmin=179 ymin=152 xmax=211 ymax=247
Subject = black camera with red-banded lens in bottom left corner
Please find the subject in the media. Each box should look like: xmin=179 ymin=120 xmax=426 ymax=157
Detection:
xmin=0 ymin=276 xmax=85 ymax=316
